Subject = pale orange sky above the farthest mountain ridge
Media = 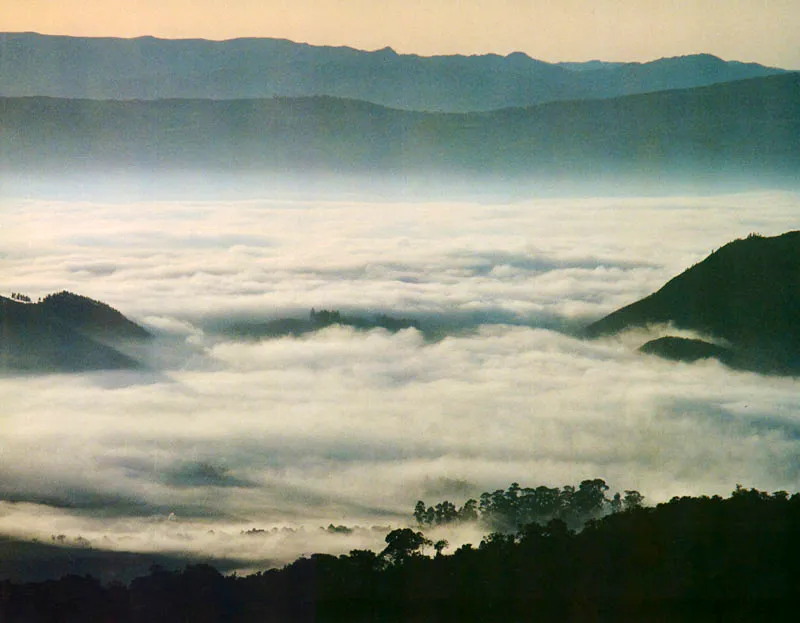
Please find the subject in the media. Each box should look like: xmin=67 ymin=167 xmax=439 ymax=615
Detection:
xmin=0 ymin=0 xmax=800 ymax=69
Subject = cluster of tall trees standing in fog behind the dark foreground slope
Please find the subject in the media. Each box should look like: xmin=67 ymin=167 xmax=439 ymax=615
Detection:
xmin=414 ymin=478 xmax=644 ymax=531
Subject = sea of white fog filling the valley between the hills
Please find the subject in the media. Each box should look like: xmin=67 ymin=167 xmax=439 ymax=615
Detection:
xmin=0 ymin=180 xmax=800 ymax=569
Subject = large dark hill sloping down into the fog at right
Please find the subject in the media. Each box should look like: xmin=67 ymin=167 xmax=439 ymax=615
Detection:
xmin=587 ymin=231 xmax=800 ymax=372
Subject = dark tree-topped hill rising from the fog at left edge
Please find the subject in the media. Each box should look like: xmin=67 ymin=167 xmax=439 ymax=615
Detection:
xmin=0 ymin=292 xmax=149 ymax=372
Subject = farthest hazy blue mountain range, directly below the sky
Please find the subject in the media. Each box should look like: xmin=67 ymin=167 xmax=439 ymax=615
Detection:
xmin=0 ymin=33 xmax=783 ymax=112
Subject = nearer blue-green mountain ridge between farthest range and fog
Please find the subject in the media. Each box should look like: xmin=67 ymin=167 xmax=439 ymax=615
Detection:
xmin=0 ymin=73 xmax=800 ymax=180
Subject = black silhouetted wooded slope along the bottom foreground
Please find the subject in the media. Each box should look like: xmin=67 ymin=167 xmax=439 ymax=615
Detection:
xmin=0 ymin=487 xmax=800 ymax=623
